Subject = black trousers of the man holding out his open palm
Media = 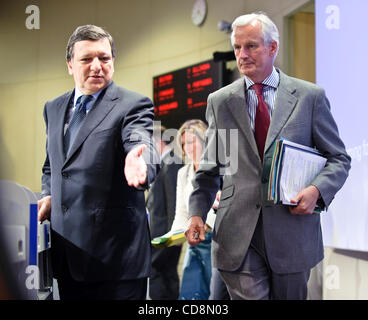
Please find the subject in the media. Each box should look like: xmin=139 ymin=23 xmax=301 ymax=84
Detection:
xmin=57 ymin=261 xmax=147 ymax=300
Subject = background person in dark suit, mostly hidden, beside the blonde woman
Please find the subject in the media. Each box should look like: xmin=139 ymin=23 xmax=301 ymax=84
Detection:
xmin=147 ymin=126 xmax=182 ymax=300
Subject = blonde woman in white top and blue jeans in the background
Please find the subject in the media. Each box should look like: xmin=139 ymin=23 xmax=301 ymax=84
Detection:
xmin=171 ymin=119 xmax=216 ymax=300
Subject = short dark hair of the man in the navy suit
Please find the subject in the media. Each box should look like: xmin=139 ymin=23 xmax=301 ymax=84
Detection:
xmin=66 ymin=24 xmax=115 ymax=61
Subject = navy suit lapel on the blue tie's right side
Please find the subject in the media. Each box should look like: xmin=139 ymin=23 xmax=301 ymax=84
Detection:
xmin=64 ymin=82 xmax=119 ymax=165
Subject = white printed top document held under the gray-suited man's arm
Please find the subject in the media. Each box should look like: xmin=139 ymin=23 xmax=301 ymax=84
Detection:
xmin=279 ymin=145 xmax=327 ymax=205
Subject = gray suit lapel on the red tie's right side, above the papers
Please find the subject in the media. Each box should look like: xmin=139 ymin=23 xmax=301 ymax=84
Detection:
xmin=265 ymin=71 xmax=298 ymax=152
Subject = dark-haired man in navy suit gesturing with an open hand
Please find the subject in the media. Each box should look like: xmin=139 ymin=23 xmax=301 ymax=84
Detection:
xmin=38 ymin=25 xmax=159 ymax=299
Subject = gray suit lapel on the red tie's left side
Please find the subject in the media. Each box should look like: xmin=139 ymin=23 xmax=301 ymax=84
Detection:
xmin=227 ymin=78 xmax=258 ymax=155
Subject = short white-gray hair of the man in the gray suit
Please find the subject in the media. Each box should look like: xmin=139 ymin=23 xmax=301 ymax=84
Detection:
xmin=231 ymin=12 xmax=279 ymax=57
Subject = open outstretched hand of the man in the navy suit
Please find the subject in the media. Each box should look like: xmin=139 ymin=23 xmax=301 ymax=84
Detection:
xmin=124 ymin=144 xmax=147 ymax=188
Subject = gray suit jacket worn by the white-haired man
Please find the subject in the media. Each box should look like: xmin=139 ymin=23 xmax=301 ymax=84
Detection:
xmin=189 ymin=70 xmax=350 ymax=273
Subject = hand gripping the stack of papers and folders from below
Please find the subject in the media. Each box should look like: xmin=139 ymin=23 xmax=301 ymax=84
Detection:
xmin=289 ymin=186 xmax=320 ymax=214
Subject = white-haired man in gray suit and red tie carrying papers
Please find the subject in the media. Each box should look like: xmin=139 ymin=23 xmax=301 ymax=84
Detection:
xmin=186 ymin=13 xmax=350 ymax=299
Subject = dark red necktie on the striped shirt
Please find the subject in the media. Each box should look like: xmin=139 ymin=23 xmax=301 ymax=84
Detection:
xmin=252 ymin=83 xmax=270 ymax=161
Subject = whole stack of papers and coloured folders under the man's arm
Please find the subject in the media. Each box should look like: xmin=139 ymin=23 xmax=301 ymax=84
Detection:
xmin=267 ymin=138 xmax=327 ymax=209
